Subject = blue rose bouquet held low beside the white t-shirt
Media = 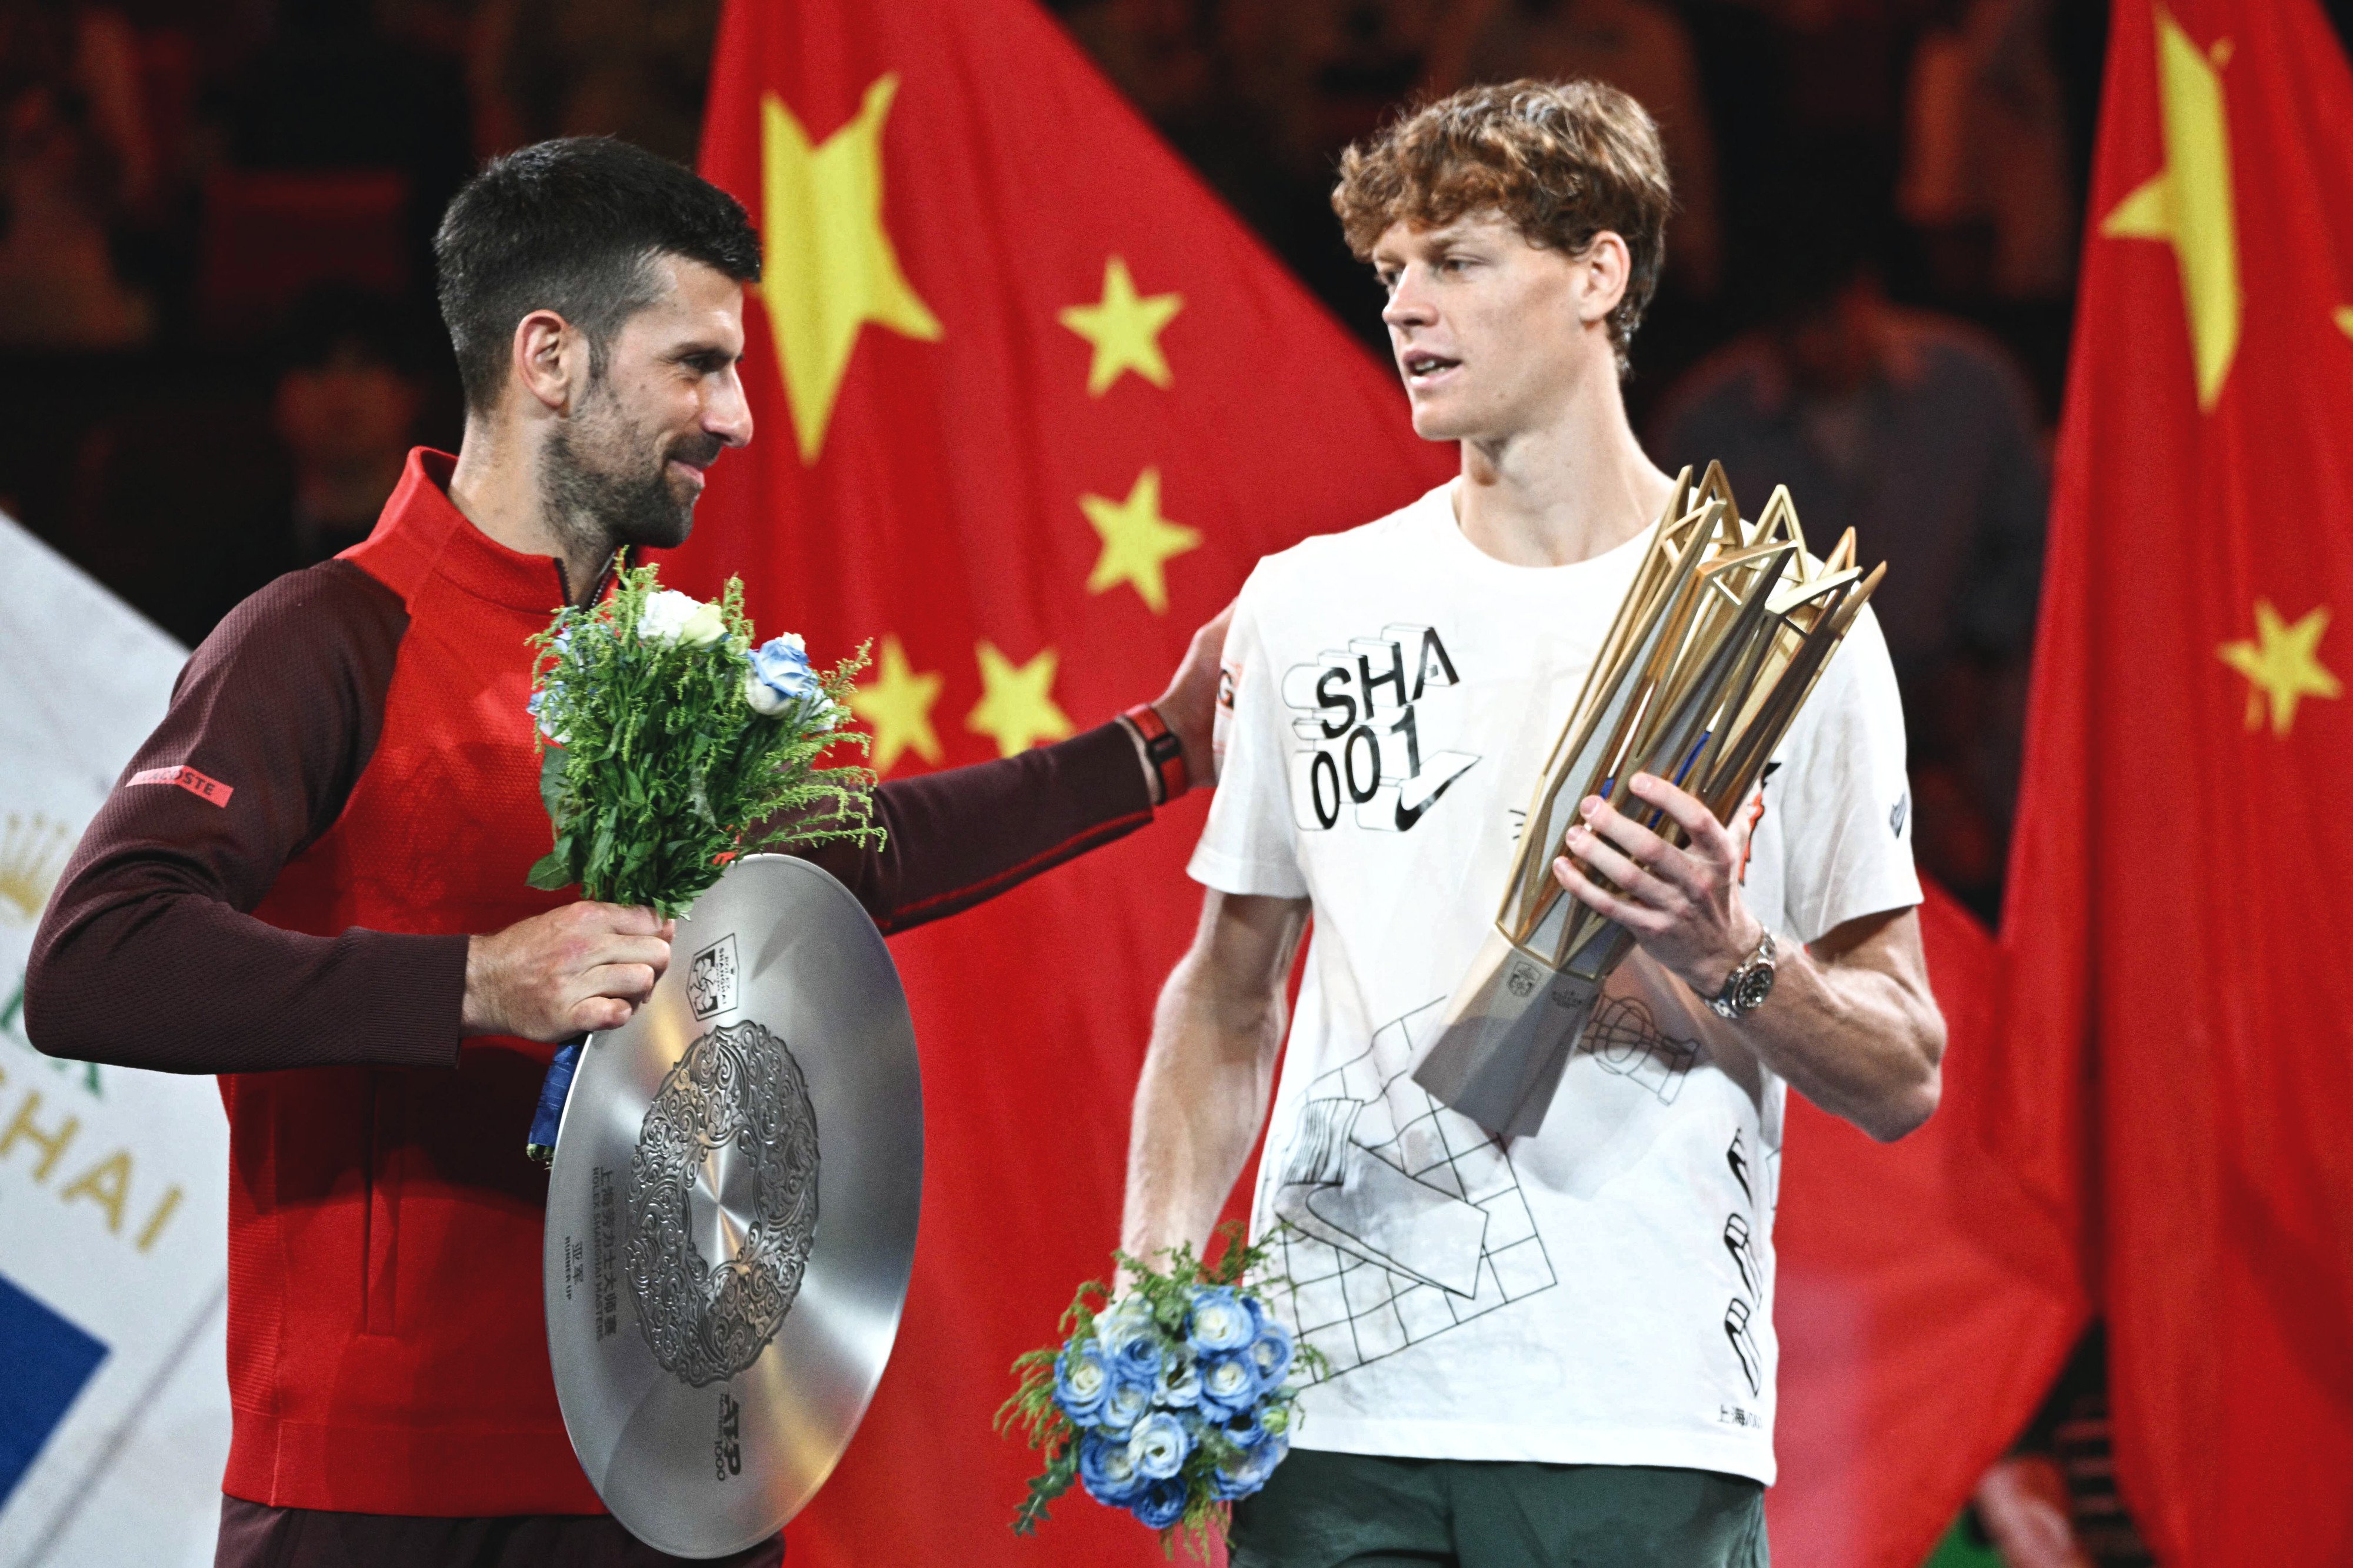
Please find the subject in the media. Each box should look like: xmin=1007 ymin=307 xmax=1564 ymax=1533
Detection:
xmin=998 ymin=1225 xmax=1322 ymax=1556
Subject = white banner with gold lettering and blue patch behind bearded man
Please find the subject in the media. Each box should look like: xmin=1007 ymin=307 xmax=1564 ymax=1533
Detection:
xmin=0 ymin=516 xmax=228 ymax=1568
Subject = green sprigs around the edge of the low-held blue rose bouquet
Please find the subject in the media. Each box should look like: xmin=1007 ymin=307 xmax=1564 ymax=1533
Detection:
xmin=995 ymin=1222 xmax=1329 ymax=1563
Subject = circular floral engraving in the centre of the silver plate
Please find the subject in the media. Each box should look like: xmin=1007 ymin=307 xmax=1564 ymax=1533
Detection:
xmin=624 ymin=1022 xmax=816 ymax=1387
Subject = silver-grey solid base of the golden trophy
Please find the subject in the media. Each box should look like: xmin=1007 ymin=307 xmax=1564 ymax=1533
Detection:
xmin=1414 ymin=935 xmax=1602 ymax=1142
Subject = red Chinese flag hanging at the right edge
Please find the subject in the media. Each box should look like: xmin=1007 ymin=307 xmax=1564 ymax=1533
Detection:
xmin=1986 ymin=0 xmax=2353 ymax=1568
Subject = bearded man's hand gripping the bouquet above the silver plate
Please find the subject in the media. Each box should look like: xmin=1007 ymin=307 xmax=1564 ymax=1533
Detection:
xmin=459 ymin=902 xmax=678 ymax=1043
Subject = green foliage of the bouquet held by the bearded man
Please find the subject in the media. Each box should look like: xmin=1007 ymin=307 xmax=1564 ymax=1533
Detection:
xmin=529 ymin=565 xmax=882 ymax=918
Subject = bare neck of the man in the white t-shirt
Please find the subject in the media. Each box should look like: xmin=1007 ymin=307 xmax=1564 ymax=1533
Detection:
xmin=1454 ymin=381 xmax=1675 ymax=568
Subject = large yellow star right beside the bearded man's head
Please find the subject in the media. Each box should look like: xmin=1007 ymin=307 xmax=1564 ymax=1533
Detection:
xmin=760 ymin=75 xmax=939 ymax=464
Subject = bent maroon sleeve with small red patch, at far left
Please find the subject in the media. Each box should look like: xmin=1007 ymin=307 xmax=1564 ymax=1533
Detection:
xmin=24 ymin=561 xmax=466 ymax=1073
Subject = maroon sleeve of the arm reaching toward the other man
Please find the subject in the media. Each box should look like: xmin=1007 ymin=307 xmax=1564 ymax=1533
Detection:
xmin=795 ymin=720 xmax=1153 ymax=932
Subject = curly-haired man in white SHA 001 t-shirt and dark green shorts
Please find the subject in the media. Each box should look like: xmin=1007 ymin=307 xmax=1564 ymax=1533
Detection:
xmin=1122 ymin=82 xmax=1944 ymax=1568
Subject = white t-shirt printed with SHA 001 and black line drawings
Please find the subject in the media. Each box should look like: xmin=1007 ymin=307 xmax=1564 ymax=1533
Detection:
xmin=1191 ymin=483 xmax=1920 ymax=1483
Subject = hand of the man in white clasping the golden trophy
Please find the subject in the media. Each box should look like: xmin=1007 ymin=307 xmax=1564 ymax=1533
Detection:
xmin=1553 ymin=772 xmax=1765 ymax=996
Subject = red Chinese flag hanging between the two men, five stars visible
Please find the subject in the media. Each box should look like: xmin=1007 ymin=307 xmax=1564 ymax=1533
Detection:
xmin=671 ymin=0 xmax=1454 ymax=1568
